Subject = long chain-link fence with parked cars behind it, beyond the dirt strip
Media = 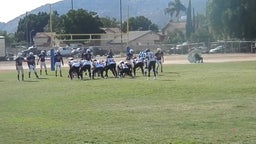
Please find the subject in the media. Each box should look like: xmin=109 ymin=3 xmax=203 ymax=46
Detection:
xmin=6 ymin=40 xmax=256 ymax=60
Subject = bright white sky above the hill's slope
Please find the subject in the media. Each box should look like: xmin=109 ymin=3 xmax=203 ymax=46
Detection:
xmin=0 ymin=0 xmax=61 ymax=22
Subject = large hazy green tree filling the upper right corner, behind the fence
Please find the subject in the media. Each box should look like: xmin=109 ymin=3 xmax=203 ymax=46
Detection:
xmin=207 ymin=0 xmax=256 ymax=39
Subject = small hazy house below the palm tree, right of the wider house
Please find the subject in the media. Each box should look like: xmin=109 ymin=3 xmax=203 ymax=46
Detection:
xmin=162 ymin=21 xmax=186 ymax=35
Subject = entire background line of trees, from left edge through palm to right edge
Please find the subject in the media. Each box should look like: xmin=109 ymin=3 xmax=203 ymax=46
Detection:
xmin=0 ymin=0 xmax=256 ymax=48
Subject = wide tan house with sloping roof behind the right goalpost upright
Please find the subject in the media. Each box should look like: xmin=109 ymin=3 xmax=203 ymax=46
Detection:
xmin=109 ymin=31 xmax=162 ymax=51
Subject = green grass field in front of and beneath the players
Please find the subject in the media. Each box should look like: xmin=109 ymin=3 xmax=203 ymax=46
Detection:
xmin=0 ymin=62 xmax=256 ymax=144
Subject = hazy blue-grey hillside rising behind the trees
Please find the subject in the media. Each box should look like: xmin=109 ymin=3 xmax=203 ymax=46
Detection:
xmin=0 ymin=0 xmax=207 ymax=32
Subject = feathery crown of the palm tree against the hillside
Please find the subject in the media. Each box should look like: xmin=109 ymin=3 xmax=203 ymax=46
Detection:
xmin=164 ymin=0 xmax=186 ymax=21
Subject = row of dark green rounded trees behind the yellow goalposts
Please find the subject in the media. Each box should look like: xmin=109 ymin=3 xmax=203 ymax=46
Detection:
xmin=15 ymin=9 xmax=158 ymax=46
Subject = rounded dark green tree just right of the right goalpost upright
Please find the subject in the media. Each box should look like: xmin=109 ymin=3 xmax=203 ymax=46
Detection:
xmin=123 ymin=16 xmax=158 ymax=32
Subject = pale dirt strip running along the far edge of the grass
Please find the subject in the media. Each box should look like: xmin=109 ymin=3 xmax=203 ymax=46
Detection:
xmin=0 ymin=54 xmax=256 ymax=71
